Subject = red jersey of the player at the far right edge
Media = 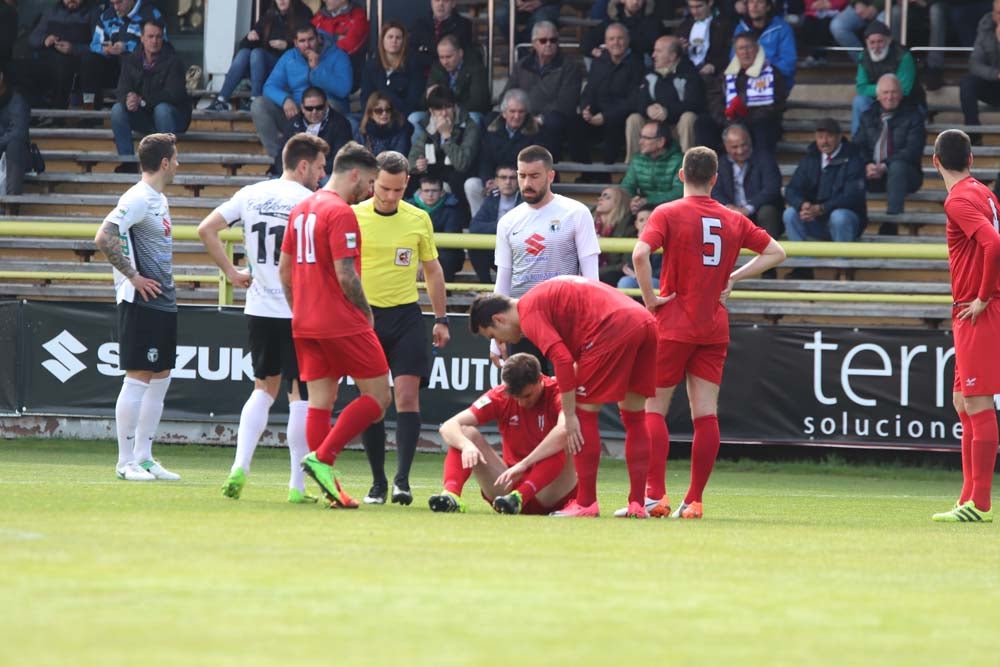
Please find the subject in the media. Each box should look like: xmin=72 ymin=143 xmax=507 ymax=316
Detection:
xmin=944 ymin=176 xmax=1000 ymax=303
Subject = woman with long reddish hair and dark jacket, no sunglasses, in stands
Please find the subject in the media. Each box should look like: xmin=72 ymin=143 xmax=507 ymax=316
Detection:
xmin=361 ymin=21 xmax=425 ymax=119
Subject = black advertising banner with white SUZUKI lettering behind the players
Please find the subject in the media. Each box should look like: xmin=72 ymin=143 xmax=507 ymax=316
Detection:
xmin=17 ymin=302 xmax=992 ymax=450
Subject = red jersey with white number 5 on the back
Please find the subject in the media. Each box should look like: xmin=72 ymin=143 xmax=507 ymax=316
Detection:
xmin=639 ymin=196 xmax=771 ymax=345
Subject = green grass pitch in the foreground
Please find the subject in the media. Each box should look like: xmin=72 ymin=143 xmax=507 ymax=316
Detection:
xmin=0 ymin=440 xmax=1000 ymax=667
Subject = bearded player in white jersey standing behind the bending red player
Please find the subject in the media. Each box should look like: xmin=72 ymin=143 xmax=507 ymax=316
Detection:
xmin=490 ymin=146 xmax=601 ymax=375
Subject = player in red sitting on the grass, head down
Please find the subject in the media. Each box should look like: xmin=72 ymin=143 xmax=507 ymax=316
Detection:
xmin=428 ymin=352 xmax=576 ymax=514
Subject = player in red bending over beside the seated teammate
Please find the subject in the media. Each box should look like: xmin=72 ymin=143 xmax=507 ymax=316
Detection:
xmin=469 ymin=276 xmax=656 ymax=519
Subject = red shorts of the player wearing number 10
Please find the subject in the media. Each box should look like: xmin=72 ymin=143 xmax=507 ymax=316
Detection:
xmin=295 ymin=329 xmax=389 ymax=382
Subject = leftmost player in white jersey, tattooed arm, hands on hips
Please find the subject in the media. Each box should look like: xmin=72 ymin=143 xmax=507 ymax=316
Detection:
xmin=94 ymin=134 xmax=180 ymax=482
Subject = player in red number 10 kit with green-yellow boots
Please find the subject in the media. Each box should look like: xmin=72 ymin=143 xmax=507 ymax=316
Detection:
xmin=278 ymin=142 xmax=390 ymax=508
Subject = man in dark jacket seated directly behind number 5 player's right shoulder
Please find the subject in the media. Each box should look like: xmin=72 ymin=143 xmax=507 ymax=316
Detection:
xmin=712 ymin=123 xmax=782 ymax=239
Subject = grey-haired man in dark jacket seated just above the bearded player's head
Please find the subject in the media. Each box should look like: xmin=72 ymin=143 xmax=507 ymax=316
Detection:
xmin=465 ymin=88 xmax=542 ymax=215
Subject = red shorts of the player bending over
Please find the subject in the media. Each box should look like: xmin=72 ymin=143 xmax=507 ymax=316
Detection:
xmin=576 ymin=318 xmax=656 ymax=403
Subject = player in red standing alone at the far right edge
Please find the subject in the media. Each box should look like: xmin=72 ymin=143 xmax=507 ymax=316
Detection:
xmin=933 ymin=130 xmax=1000 ymax=522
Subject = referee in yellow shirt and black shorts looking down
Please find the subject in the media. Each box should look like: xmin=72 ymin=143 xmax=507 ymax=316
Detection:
xmin=353 ymin=151 xmax=451 ymax=505
